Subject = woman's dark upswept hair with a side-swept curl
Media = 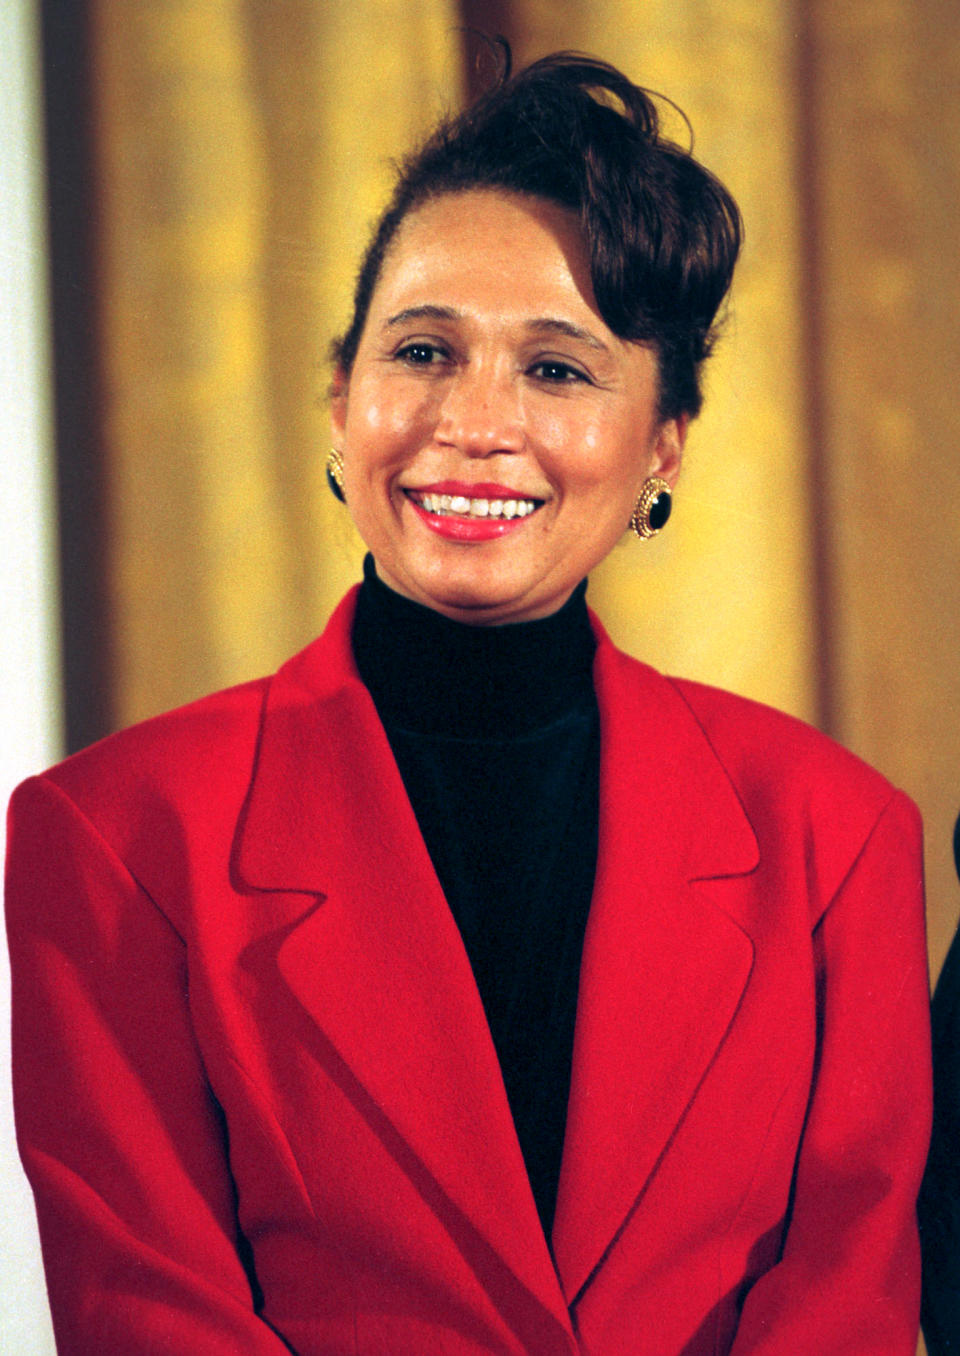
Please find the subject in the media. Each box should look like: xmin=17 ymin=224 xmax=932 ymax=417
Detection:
xmin=332 ymin=43 xmax=742 ymax=419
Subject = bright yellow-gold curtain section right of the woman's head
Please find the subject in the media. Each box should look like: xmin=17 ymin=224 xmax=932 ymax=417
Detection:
xmin=515 ymin=0 xmax=819 ymax=720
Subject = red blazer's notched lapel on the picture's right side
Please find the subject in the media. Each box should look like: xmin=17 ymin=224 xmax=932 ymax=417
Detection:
xmin=553 ymin=626 xmax=757 ymax=1303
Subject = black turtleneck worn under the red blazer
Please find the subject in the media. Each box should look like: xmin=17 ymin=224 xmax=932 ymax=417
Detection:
xmin=353 ymin=556 xmax=599 ymax=1238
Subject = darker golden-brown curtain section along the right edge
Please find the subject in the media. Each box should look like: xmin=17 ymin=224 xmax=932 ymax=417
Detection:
xmin=805 ymin=0 xmax=960 ymax=971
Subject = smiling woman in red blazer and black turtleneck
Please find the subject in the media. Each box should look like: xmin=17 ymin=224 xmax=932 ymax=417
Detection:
xmin=3 ymin=56 xmax=929 ymax=1356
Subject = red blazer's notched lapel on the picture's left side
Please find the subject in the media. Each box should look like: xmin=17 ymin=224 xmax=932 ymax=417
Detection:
xmin=237 ymin=595 xmax=572 ymax=1349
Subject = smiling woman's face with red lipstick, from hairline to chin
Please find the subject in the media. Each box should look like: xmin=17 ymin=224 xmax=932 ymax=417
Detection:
xmin=332 ymin=191 xmax=685 ymax=624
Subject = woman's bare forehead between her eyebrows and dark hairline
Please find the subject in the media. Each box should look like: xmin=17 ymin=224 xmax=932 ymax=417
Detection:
xmin=373 ymin=190 xmax=606 ymax=328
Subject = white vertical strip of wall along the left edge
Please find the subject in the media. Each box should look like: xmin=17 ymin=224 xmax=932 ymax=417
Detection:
xmin=0 ymin=0 xmax=61 ymax=1356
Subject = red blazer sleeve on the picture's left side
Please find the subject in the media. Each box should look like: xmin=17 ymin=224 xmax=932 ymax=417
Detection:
xmin=7 ymin=778 xmax=290 ymax=1356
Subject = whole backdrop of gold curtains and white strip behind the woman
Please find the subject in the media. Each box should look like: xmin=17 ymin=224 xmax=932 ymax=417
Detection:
xmin=0 ymin=0 xmax=960 ymax=1356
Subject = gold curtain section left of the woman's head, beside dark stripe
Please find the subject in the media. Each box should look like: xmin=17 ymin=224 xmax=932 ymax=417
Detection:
xmin=92 ymin=0 xmax=461 ymax=724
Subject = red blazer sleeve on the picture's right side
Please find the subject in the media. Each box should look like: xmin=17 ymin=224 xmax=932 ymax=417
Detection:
xmin=732 ymin=793 xmax=932 ymax=1356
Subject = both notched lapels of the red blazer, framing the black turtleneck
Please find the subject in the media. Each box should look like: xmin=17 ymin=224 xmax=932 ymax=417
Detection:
xmin=235 ymin=590 xmax=757 ymax=1323
